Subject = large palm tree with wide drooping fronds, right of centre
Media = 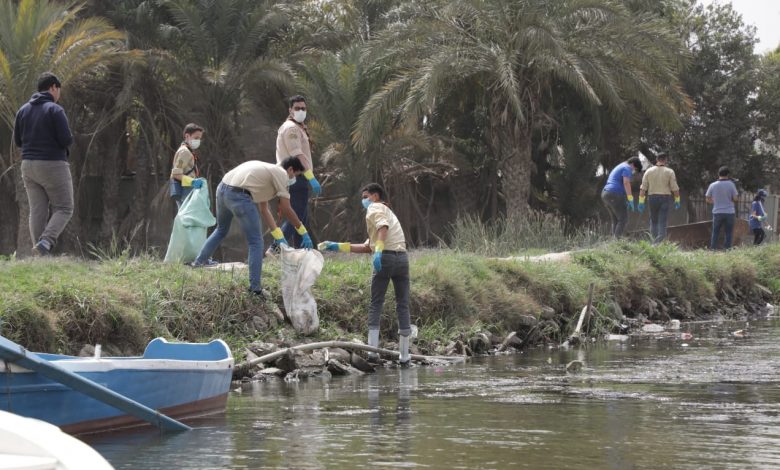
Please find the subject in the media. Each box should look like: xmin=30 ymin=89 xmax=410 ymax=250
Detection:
xmin=353 ymin=0 xmax=688 ymax=217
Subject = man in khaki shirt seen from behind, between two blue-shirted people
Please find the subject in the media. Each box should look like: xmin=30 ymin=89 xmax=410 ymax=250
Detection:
xmin=637 ymin=153 xmax=680 ymax=245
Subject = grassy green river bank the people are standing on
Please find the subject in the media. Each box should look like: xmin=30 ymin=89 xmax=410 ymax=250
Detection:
xmin=0 ymin=242 xmax=780 ymax=356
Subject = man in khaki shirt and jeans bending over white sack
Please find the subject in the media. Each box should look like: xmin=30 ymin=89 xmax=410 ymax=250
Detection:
xmin=192 ymin=158 xmax=313 ymax=297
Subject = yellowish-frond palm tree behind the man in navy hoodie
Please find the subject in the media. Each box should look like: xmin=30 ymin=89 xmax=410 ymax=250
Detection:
xmin=0 ymin=0 xmax=125 ymax=253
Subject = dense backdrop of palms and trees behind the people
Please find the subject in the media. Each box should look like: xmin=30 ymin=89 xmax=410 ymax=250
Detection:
xmin=0 ymin=0 xmax=780 ymax=254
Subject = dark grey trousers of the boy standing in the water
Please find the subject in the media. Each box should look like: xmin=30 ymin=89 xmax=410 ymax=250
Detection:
xmin=368 ymin=251 xmax=412 ymax=336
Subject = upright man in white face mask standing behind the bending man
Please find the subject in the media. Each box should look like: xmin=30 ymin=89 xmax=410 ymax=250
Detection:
xmin=268 ymin=95 xmax=321 ymax=253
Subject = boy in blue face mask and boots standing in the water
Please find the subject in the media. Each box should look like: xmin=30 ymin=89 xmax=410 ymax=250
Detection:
xmin=318 ymin=183 xmax=412 ymax=367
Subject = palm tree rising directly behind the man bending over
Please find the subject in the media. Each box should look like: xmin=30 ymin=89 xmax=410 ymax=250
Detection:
xmin=158 ymin=0 xmax=293 ymax=174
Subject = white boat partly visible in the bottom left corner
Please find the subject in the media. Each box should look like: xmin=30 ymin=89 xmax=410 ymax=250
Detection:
xmin=0 ymin=410 xmax=114 ymax=470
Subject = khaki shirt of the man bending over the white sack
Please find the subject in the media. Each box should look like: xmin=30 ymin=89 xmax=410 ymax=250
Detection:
xmin=222 ymin=160 xmax=290 ymax=203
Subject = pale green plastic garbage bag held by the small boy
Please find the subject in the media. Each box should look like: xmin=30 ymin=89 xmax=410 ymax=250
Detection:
xmin=165 ymin=178 xmax=217 ymax=263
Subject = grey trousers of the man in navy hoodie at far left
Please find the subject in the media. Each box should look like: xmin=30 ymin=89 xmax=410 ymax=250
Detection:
xmin=22 ymin=160 xmax=73 ymax=246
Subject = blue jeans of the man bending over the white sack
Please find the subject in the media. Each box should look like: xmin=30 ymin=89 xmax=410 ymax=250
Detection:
xmin=195 ymin=183 xmax=263 ymax=291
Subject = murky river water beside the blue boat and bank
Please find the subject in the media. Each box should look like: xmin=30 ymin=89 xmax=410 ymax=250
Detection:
xmin=87 ymin=319 xmax=780 ymax=469
